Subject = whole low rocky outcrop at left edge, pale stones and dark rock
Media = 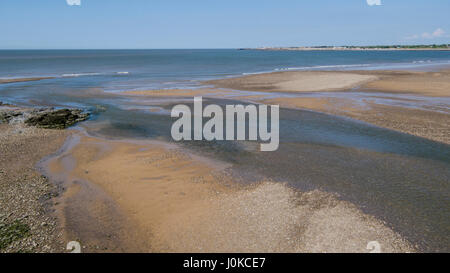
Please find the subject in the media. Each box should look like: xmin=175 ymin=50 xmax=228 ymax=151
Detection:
xmin=0 ymin=107 xmax=89 ymax=129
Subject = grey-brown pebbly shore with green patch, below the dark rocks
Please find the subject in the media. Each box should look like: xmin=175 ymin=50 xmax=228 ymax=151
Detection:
xmin=0 ymin=120 xmax=71 ymax=253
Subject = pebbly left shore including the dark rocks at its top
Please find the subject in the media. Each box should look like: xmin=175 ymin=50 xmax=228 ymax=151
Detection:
xmin=0 ymin=102 xmax=89 ymax=253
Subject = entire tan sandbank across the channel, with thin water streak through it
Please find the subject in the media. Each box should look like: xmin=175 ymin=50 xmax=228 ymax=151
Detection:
xmin=127 ymin=68 xmax=450 ymax=144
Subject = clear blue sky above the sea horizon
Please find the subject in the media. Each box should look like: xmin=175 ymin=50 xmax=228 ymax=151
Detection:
xmin=0 ymin=0 xmax=450 ymax=49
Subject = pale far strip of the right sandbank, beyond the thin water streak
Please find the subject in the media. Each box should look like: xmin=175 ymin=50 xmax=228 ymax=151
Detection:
xmin=206 ymin=69 xmax=450 ymax=97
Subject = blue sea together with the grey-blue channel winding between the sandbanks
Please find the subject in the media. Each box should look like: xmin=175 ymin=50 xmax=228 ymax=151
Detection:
xmin=0 ymin=50 xmax=450 ymax=252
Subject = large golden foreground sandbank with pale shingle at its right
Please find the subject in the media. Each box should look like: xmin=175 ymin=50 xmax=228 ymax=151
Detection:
xmin=47 ymin=133 xmax=414 ymax=252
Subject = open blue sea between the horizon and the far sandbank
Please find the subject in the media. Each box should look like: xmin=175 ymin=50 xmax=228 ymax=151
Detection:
xmin=0 ymin=49 xmax=450 ymax=91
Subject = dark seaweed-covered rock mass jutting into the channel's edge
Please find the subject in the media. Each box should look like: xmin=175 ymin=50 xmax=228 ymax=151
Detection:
xmin=25 ymin=109 xmax=89 ymax=129
